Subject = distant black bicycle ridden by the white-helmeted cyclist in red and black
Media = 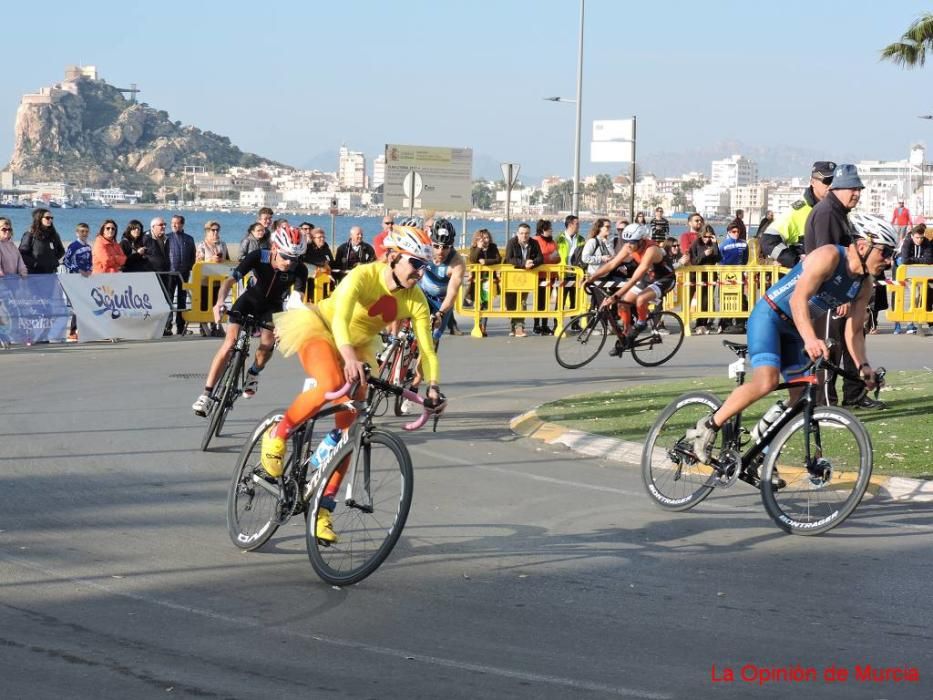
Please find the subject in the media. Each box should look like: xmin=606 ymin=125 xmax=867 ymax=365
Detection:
xmin=554 ymin=286 xmax=684 ymax=369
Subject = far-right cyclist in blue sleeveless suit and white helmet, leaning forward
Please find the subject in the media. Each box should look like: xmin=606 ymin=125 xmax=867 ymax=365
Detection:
xmin=687 ymin=212 xmax=897 ymax=462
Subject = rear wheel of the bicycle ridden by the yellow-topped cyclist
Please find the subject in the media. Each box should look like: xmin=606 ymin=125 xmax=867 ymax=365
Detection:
xmin=227 ymin=411 xmax=292 ymax=552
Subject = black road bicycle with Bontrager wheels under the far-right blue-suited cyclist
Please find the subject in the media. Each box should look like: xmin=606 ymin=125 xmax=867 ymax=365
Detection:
xmin=641 ymin=340 xmax=885 ymax=535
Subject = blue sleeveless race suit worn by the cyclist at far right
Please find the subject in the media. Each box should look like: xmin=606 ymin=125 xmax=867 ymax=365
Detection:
xmin=748 ymin=246 xmax=866 ymax=376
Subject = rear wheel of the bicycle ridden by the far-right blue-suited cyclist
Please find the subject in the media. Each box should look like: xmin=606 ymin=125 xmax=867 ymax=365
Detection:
xmin=641 ymin=391 xmax=725 ymax=511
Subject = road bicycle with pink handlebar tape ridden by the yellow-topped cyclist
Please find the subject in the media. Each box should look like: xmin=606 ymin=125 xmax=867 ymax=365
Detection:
xmin=227 ymin=367 xmax=439 ymax=586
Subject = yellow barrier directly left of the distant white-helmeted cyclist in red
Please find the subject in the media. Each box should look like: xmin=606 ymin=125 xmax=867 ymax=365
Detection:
xmin=456 ymin=264 xmax=590 ymax=338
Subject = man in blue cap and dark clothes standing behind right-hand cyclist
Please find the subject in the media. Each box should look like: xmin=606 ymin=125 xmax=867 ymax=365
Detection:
xmin=803 ymin=163 xmax=886 ymax=409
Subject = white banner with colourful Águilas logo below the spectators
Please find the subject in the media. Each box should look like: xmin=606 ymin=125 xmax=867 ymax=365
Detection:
xmin=58 ymin=272 xmax=171 ymax=341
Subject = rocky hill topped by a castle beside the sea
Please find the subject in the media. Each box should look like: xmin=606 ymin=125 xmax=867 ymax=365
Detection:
xmin=9 ymin=68 xmax=279 ymax=187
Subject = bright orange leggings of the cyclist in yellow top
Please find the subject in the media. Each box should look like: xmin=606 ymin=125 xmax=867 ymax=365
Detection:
xmin=274 ymin=338 xmax=366 ymax=499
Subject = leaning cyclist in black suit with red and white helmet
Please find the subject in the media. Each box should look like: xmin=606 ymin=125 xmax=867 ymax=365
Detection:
xmin=191 ymin=226 xmax=308 ymax=416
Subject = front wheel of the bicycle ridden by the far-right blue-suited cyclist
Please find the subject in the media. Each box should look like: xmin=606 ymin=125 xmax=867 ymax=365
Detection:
xmin=761 ymin=406 xmax=873 ymax=535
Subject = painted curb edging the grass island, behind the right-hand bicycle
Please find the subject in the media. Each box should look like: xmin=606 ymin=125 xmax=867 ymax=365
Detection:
xmin=509 ymin=408 xmax=933 ymax=503
